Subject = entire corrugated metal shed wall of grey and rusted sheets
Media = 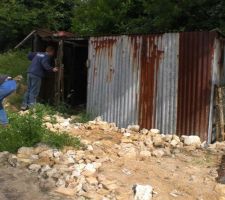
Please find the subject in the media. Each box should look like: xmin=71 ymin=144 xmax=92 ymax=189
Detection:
xmin=87 ymin=32 xmax=225 ymax=140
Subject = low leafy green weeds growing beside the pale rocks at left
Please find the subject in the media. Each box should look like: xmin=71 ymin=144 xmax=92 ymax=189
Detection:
xmin=0 ymin=105 xmax=81 ymax=152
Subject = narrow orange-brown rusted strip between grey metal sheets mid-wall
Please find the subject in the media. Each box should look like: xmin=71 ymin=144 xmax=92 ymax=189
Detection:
xmin=139 ymin=35 xmax=163 ymax=129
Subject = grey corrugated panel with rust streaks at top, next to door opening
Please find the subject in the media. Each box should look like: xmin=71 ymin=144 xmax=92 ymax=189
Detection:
xmin=87 ymin=36 xmax=141 ymax=127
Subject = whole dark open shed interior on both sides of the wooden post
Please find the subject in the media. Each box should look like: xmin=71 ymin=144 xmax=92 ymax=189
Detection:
xmin=33 ymin=35 xmax=88 ymax=109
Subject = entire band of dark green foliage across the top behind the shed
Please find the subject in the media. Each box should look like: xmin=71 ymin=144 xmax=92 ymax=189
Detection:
xmin=0 ymin=0 xmax=225 ymax=49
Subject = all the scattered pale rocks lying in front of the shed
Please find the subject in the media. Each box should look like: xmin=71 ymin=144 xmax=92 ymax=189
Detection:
xmin=0 ymin=115 xmax=225 ymax=200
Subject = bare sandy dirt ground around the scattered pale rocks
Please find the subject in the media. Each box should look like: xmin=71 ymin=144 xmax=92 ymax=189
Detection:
xmin=0 ymin=126 xmax=221 ymax=200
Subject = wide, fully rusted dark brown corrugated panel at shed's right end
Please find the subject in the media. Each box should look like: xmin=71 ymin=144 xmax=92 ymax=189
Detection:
xmin=177 ymin=32 xmax=216 ymax=140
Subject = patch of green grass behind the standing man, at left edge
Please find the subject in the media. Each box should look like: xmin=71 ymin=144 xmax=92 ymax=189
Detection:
xmin=0 ymin=50 xmax=30 ymax=78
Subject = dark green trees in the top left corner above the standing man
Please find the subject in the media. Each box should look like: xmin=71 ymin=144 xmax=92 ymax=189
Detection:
xmin=0 ymin=0 xmax=74 ymax=49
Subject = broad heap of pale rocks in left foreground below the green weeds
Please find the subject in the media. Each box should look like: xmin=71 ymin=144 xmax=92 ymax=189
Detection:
xmin=0 ymin=144 xmax=118 ymax=200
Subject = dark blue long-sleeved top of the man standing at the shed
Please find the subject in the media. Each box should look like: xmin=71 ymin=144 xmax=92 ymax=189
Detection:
xmin=27 ymin=52 xmax=53 ymax=78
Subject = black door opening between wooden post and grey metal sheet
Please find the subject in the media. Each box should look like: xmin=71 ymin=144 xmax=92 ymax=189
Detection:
xmin=63 ymin=40 xmax=88 ymax=107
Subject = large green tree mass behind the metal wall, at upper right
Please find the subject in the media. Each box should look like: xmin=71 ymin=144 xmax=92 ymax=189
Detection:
xmin=72 ymin=0 xmax=225 ymax=35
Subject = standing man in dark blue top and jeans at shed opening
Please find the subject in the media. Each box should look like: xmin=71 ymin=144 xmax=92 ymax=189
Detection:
xmin=21 ymin=46 xmax=58 ymax=110
